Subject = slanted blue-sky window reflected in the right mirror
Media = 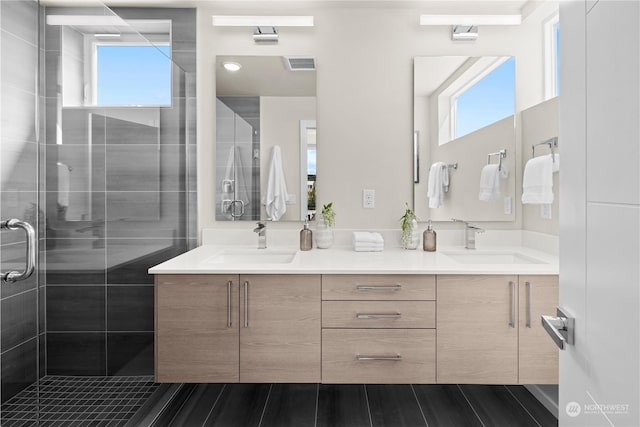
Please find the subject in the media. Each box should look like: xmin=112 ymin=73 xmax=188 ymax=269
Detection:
xmin=452 ymin=57 xmax=515 ymax=139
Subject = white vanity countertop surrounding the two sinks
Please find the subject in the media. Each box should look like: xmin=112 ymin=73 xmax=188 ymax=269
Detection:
xmin=149 ymin=245 xmax=558 ymax=275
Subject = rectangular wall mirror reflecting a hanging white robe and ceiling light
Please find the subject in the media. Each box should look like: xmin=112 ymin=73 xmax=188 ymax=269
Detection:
xmin=215 ymin=56 xmax=316 ymax=221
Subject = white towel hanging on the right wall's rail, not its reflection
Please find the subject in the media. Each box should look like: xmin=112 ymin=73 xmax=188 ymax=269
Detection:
xmin=522 ymin=155 xmax=559 ymax=205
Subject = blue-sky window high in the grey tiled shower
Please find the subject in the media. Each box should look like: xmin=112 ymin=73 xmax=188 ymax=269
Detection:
xmin=93 ymin=43 xmax=171 ymax=105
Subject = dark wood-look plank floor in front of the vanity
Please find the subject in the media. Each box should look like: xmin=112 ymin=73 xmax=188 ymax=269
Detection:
xmin=163 ymin=384 xmax=558 ymax=427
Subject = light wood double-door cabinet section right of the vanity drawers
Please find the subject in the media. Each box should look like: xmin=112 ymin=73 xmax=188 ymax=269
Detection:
xmin=437 ymin=275 xmax=558 ymax=384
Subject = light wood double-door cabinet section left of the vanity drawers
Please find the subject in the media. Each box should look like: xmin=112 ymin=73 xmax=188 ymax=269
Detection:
xmin=155 ymin=274 xmax=320 ymax=383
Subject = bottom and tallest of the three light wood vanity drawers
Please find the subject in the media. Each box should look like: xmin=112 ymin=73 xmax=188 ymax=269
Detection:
xmin=322 ymin=329 xmax=436 ymax=384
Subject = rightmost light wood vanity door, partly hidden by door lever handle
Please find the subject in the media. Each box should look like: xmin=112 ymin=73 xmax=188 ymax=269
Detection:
xmin=518 ymin=276 xmax=559 ymax=384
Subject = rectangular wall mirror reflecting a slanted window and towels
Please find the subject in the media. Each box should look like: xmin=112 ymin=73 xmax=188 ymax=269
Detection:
xmin=413 ymin=56 xmax=518 ymax=221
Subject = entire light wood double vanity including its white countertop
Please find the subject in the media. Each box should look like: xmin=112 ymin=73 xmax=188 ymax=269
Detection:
xmin=150 ymin=245 xmax=558 ymax=384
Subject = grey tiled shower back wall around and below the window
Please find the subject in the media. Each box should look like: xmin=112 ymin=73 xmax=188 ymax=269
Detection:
xmin=45 ymin=8 xmax=197 ymax=375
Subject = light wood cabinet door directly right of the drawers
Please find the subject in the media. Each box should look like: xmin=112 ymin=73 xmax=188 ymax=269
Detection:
xmin=436 ymin=275 xmax=518 ymax=384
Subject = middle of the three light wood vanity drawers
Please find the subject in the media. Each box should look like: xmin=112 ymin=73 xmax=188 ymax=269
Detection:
xmin=322 ymin=301 xmax=436 ymax=328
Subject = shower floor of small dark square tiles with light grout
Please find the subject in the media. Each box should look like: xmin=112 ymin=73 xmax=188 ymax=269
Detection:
xmin=0 ymin=376 xmax=159 ymax=427
